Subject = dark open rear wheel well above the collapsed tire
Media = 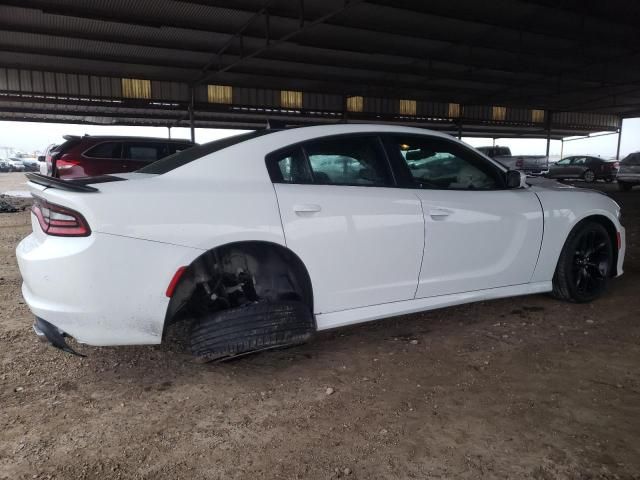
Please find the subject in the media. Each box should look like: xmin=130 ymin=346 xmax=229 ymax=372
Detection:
xmin=164 ymin=241 xmax=313 ymax=332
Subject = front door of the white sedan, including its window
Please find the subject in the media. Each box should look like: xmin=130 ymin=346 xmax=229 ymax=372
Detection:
xmin=384 ymin=135 xmax=543 ymax=298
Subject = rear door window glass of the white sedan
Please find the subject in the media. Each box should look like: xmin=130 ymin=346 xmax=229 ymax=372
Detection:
xmin=304 ymin=137 xmax=392 ymax=186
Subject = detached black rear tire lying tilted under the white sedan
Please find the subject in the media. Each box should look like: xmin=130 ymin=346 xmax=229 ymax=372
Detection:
xmin=191 ymin=301 xmax=315 ymax=361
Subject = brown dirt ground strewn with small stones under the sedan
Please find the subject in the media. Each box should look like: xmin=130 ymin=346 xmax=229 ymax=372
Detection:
xmin=0 ymin=177 xmax=640 ymax=480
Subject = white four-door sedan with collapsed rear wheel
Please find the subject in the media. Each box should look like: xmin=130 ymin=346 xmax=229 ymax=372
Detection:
xmin=17 ymin=125 xmax=625 ymax=359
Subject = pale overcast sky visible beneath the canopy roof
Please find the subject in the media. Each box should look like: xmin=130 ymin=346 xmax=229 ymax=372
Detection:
xmin=0 ymin=118 xmax=640 ymax=158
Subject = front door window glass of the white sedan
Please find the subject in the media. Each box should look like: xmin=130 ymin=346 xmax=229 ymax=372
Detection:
xmin=386 ymin=135 xmax=503 ymax=190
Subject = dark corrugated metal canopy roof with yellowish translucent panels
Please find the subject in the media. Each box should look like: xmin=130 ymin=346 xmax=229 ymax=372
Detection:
xmin=0 ymin=0 xmax=640 ymax=138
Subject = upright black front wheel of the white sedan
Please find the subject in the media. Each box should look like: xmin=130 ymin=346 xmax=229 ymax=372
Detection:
xmin=553 ymin=221 xmax=614 ymax=303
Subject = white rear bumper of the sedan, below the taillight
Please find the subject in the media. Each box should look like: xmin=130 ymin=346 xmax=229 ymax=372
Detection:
xmin=16 ymin=223 xmax=200 ymax=346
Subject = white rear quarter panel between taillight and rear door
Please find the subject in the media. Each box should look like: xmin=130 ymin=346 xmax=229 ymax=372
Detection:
xmin=33 ymin=142 xmax=284 ymax=250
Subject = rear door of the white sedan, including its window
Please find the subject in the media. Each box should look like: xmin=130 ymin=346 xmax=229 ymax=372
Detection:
xmin=267 ymin=135 xmax=424 ymax=313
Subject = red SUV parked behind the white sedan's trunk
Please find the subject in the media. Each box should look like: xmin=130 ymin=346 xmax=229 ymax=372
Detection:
xmin=45 ymin=135 xmax=195 ymax=178
